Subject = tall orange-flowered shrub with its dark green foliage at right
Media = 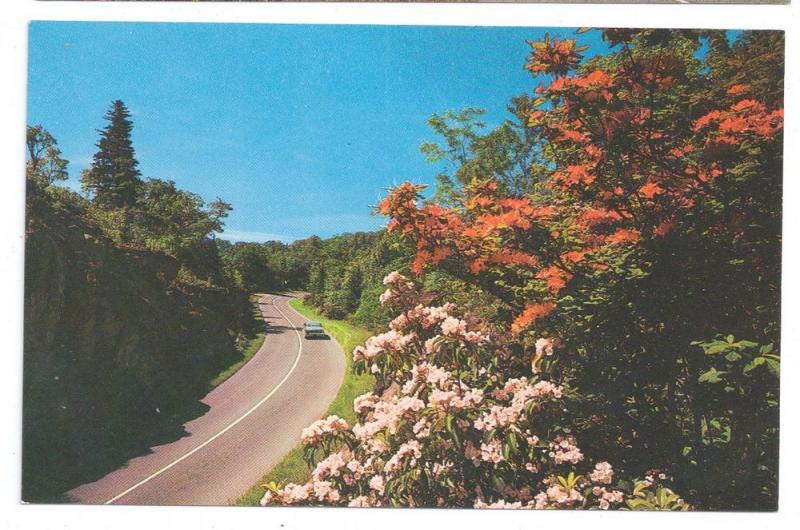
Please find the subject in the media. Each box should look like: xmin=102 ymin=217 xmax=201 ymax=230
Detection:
xmin=378 ymin=30 xmax=783 ymax=509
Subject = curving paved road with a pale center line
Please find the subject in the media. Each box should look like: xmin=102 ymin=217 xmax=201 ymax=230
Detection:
xmin=68 ymin=295 xmax=345 ymax=505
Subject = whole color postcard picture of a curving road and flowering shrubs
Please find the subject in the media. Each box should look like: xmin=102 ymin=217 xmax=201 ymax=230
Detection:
xmin=20 ymin=21 xmax=784 ymax=511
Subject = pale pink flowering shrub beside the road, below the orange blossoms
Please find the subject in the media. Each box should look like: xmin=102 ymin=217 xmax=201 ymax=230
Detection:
xmin=262 ymin=272 xmax=688 ymax=510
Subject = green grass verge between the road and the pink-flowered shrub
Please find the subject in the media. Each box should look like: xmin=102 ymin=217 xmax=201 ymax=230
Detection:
xmin=236 ymin=299 xmax=375 ymax=506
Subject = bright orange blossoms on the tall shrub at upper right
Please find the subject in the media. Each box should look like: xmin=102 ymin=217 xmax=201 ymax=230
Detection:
xmin=381 ymin=29 xmax=783 ymax=332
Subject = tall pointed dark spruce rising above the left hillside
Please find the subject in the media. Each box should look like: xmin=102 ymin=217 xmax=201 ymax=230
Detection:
xmin=81 ymin=100 xmax=142 ymax=208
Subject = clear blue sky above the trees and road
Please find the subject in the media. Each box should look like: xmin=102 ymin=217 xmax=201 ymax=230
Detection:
xmin=28 ymin=22 xmax=605 ymax=241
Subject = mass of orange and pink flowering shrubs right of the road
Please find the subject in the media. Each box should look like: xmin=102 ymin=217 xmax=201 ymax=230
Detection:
xmin=255 ymin=29 xmax=784 ymax=510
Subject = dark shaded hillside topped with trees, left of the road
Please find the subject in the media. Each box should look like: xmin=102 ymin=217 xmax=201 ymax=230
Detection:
xmin=23 ymin=102 xmax=252 ymax=501
